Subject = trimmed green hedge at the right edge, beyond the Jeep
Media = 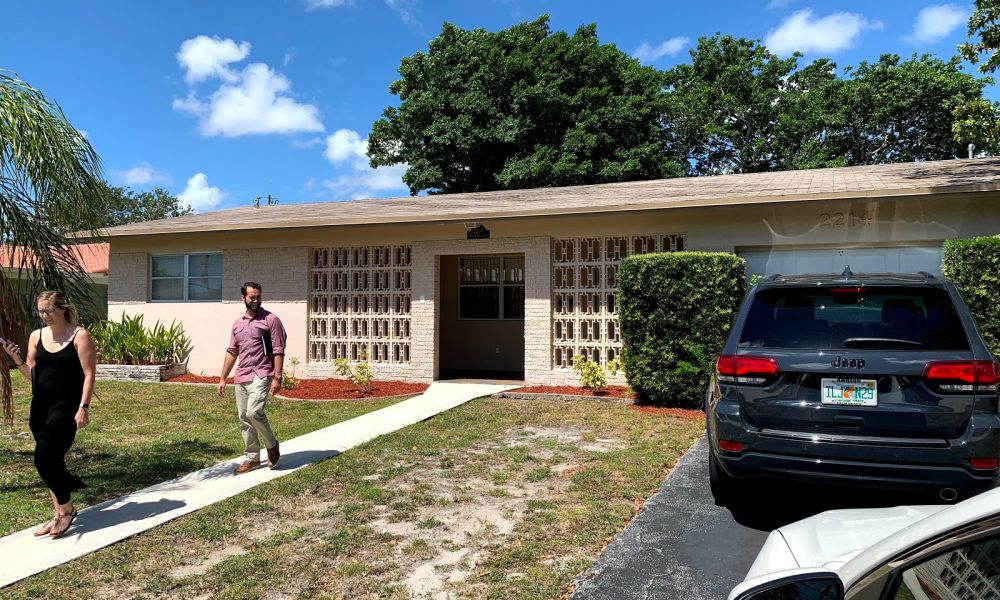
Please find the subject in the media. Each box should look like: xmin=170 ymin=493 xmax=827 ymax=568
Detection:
xmin=941 ymin=236 xmax=1000 ymax=356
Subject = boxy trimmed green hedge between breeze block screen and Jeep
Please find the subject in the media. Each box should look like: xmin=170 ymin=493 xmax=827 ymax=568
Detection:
xmin=617 ymin=252 xmax=746 ymax=408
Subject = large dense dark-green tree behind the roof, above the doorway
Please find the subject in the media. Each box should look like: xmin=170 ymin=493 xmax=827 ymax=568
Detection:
xmin=368 ymin=16 xmax=681 ymax=194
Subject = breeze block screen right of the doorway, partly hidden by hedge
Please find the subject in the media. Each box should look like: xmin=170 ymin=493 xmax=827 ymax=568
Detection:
xmin=552 ymin=233 xmax=685 ymax=369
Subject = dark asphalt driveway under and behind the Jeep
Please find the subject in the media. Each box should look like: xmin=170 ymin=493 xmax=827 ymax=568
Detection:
xmin=570 ymin=436 xmax=935 ymax=600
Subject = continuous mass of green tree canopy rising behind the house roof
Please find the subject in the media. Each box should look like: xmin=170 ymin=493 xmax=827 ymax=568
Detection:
xmin=368 ymin=20 xmax=1000 ymax=194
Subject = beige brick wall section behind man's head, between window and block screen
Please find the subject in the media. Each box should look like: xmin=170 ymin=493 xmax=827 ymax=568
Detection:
xmin=222 ymin=247 xmax=309 ymax=302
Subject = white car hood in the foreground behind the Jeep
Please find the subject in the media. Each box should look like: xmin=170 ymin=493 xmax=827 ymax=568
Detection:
xmin=747 ymin=505 xmax=947 ymax=579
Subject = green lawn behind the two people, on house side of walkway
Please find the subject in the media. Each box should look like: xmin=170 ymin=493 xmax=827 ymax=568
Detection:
xmin=0 ymin=372 xmax=399 ymax=535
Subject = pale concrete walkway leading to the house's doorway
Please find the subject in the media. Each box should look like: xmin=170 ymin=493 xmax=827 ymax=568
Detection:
xmin=0 ymin=383 xmax=518 ymax=588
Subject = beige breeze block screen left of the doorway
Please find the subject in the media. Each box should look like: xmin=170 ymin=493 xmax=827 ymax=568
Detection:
xmin=309 ymin=246 xmax=411 ymax=364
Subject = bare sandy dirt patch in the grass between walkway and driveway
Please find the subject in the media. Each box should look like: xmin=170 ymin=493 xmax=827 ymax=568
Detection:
xmin=348 ymin=427 xmax=625 ymax=599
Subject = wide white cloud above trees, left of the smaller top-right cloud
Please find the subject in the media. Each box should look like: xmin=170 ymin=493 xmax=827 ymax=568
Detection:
xmin=764 ymin=9 xmax=883 ymax=56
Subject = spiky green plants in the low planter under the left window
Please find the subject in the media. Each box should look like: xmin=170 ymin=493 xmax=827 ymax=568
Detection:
xmin=89 ymin=315 xmax=191 ymax=365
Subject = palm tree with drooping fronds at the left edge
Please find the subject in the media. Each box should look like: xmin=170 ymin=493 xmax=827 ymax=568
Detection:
xmin=0 ymin=71 xmax=104 ymax=423
